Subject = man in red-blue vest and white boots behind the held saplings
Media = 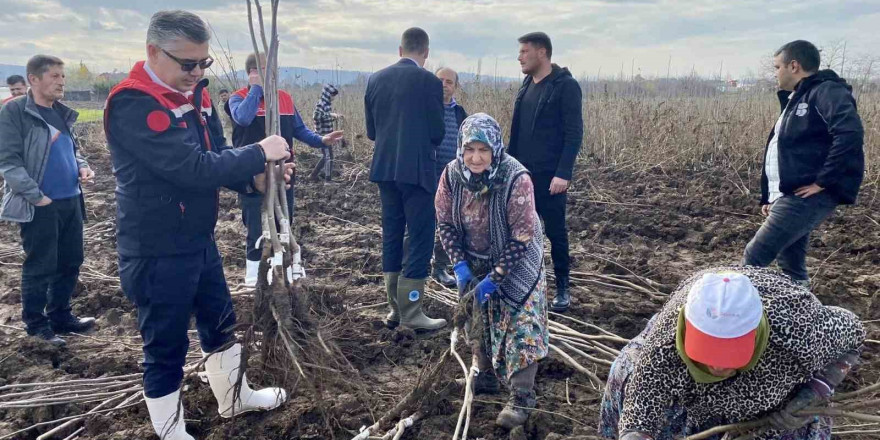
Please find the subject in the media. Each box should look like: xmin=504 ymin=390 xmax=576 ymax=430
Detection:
xmin=229 ymin=54 xmax=342 ymax=287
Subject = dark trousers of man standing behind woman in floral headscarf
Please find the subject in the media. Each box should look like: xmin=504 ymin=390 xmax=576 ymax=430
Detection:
xmin=532 ymin=173 xmax=571 ymax=276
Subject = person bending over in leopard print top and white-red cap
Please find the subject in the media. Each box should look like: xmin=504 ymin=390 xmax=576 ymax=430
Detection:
xmin=600 ymin=267 xmax=865 ymax=440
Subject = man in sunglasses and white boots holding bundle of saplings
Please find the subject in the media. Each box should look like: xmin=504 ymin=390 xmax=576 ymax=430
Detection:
xmin=104 ymin=11 xmax=292 ymax=440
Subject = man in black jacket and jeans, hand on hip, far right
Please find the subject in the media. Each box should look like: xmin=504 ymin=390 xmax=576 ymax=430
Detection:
xmin=743 ymin=40 xmax=865 ymax=287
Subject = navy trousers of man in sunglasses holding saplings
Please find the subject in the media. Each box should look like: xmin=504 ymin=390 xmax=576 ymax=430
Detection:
xmin=119 ymin=243 xmax=235 ymax=399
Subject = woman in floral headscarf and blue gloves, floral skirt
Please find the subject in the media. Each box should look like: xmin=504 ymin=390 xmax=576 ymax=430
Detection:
xmin=435 ymin=113 xmax=549 ymax=429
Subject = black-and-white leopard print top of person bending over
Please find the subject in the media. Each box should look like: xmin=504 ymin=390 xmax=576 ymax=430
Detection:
xmin=618 ymin=267 xmax=865 ymax=438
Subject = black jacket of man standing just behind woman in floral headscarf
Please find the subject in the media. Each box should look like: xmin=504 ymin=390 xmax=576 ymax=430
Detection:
xmin=508 ymin=64 xmax=584 ymax=180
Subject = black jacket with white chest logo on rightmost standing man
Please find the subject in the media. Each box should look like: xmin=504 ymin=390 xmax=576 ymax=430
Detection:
xmin=761 ymin=70 xmax=865 ymax=205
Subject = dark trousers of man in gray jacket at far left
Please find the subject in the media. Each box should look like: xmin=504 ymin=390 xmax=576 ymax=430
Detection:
xmin=20 ymin=197 xmax=83 ymax=334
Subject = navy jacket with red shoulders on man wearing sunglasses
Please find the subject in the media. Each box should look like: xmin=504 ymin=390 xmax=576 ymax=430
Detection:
xmin=104 ymin=61 xmax=265 ymax=257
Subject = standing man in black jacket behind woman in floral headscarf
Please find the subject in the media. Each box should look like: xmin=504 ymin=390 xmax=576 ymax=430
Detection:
xmin=508 ymin=32 xmax=584 ymax=312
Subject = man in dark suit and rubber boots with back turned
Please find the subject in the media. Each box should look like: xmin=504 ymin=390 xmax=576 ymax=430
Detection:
xmin=364 ymin=28 xmax=446 ymax=330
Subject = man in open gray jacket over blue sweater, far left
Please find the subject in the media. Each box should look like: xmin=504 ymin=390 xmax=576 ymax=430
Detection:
xmin=0 ymin=55 xmax=95 ymax=345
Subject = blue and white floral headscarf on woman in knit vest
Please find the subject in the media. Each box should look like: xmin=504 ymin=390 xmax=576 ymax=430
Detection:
xmin=455 ymin=113 xmax=504 ymax=194
